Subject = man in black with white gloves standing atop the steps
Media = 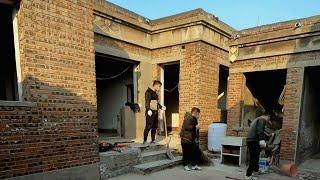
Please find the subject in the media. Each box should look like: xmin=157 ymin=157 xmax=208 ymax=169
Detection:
xmin=143 ymin=81 xmax=166 ymax=144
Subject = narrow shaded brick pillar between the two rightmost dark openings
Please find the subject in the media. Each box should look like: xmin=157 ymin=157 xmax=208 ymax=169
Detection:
xmin=281 ymin=67 xmax=304 ymax=161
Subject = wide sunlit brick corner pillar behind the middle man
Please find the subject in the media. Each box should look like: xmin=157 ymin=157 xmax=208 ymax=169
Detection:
xmin=179 ymin=42 xmax=228 ymax=145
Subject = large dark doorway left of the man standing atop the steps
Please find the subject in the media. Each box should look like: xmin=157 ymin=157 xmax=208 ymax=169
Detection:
xmin=95 ymin=55 xmax=134 ymax=136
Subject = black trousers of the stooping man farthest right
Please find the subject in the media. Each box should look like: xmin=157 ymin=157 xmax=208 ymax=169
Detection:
xmin=246 ymin=142 xmax=261 ymax=176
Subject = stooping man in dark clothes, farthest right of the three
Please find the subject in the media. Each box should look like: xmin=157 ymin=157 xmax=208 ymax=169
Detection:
xmin=246 ymin=114 xmax=271 ymax=180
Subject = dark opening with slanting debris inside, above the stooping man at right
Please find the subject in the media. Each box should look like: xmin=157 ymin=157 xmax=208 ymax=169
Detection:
xmin=242 ymin=69 xmax=287 ymax=129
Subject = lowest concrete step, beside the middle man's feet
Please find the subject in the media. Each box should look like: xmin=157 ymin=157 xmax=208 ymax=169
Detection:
xmin=133 ymin=156 xmax=182 ymax=174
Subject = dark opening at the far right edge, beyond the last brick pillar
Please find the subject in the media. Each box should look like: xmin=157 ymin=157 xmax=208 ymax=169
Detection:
xmin=297 ymin=66 xmax=320 ymax=162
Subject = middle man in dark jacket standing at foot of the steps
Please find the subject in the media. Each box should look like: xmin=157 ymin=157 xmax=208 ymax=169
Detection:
xmin=180 ymin=107 xmax=201 ymax=171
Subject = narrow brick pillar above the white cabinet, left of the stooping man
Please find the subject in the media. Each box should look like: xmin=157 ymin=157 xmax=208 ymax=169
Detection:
xmin=227 ymin=73 xmax=245 ymax=136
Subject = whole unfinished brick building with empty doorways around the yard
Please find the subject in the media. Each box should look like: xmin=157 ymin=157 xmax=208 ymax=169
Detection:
xmin=0 ymin=0 xmax=320 ymax=179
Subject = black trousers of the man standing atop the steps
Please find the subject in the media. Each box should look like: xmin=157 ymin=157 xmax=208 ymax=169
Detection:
xmin=143 ymin=111 xmax=158 ymax=141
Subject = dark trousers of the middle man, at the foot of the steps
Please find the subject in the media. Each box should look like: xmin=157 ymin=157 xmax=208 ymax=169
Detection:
xmin=181 ymin=143 xmax=200 ymax=166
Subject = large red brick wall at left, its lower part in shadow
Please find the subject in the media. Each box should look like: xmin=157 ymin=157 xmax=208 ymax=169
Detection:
xmin=0 ymin=0 xmax=99 ymax=178
